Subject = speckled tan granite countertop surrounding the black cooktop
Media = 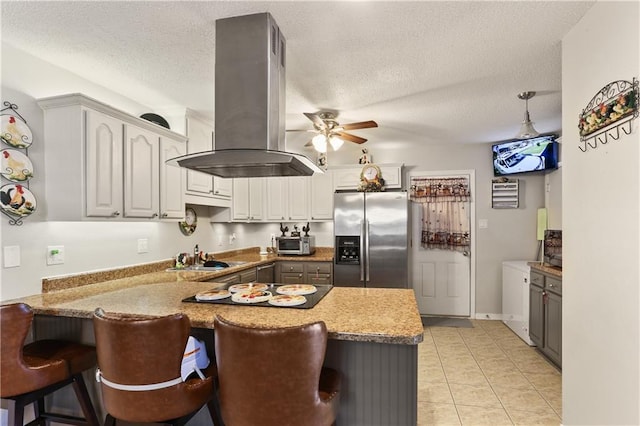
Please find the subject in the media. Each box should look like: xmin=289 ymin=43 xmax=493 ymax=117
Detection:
xmin=11 ymin=248 xmax=424 ymax=345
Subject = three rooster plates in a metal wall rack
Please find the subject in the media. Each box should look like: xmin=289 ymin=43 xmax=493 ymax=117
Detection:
xmin=0 ymin=102 xmax=36 ymax=226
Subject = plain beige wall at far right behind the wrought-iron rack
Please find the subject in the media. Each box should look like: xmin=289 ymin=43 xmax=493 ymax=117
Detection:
xmin=562 ymin=2 xmax=640 ymax=425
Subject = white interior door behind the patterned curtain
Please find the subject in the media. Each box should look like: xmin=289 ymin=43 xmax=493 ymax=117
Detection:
xmin=411 ymin=172 xmax=475 ymax=317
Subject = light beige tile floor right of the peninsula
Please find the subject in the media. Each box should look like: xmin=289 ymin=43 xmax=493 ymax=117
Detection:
xmin=418 ymin=320 xmax=562 ymax=426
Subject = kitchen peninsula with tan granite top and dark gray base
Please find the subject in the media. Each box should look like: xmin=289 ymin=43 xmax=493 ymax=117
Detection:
xmin=8 ymin=250 xmax=423 ymax=425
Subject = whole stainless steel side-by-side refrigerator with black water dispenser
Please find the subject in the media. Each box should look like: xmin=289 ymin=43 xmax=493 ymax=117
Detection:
xmin=333 ymin=191 xmax=409 ymax=288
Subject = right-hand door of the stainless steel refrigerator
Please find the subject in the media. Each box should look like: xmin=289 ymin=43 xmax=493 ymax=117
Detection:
xmin=363 ymin=192 xmax=409 ymax=288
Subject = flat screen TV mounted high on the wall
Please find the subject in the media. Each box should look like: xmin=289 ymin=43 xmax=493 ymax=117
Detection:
xmin=492 ymin=135 xmax=558 ymax=176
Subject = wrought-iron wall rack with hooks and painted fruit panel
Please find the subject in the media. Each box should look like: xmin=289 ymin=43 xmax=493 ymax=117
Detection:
xmin=578 ymin=77 xmax=640 ymax=152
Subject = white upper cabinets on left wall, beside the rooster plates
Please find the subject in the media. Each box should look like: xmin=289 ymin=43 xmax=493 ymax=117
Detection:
xmin=38 ymin=93 xmax=187 ymax=221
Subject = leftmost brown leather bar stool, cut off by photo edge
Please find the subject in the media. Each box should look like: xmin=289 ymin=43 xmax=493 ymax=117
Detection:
xmin=0 ymin=303 xmax=100 ymax=426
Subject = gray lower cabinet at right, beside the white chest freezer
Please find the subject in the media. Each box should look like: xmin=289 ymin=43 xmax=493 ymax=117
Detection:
xmin=529 ymin=271 xmax=562 ymax=367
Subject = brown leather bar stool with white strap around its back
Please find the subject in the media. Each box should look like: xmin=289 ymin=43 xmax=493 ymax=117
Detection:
xmin=93 ymin=309 xmax=218 ymax=425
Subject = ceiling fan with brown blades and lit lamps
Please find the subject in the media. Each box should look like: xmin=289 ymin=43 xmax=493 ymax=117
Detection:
xmin=288 ymin=112 xmax=378 ymax=152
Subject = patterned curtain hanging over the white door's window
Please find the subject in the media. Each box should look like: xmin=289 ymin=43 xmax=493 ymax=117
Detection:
xmin=410 ymin=177 xmax=471 ymax=252
